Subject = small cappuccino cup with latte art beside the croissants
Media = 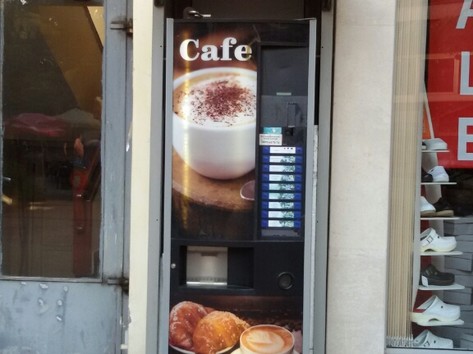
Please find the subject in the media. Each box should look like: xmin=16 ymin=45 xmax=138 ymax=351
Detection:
xmin=240 ymin=325 xmax=294 ymax=354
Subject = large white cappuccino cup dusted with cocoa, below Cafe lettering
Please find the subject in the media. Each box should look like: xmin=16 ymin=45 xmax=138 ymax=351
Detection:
xmin=173 ymin=67 xmax=256 ymax=180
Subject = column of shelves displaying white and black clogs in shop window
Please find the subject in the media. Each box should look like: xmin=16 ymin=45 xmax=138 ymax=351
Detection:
xmin=414 ymin=122 xmax=462 ymax=342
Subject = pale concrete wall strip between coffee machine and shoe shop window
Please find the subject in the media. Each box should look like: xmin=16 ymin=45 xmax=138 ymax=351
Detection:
xmin=326 ymin=0 xmax=396 ymax=354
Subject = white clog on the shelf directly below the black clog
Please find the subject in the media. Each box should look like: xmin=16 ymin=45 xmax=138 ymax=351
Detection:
xmin=411 ymin=295 xmax=460 ymax=325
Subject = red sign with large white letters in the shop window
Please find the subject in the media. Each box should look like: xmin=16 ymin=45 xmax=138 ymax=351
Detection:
xmin=424 ymin=0 xmax=473 ymax=168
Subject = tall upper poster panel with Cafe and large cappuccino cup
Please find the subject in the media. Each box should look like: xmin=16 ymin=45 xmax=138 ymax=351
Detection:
xmin=167 ymin=23 xmax=258 ymax=240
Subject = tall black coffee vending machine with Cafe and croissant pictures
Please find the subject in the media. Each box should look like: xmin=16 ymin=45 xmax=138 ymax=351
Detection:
xmin=159 ymin=19 xmax=318 ymax=354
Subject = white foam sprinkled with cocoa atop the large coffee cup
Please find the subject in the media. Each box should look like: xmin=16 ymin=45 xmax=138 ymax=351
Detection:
xmin=175 ymin=74 xmax=256 ymax=127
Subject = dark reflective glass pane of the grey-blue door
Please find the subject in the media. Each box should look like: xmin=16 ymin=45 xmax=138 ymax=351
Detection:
xmin=0 ymin=1 xmax=103 ymax=277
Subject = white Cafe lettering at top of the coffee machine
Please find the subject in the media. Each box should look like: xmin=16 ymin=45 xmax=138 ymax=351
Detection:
xmin=179 ymin=37 xmax=251 ymax=61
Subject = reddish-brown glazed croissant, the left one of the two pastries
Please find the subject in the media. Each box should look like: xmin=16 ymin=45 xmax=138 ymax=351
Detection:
xmin=169 ymin=301 xmax=212 ymax=351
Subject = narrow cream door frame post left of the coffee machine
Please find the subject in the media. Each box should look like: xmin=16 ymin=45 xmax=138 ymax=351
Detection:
xmin=128 ymin=0 xmax=165 ymax=354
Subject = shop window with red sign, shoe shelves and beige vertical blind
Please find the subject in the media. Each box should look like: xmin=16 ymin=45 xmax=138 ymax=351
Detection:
xmin=387 ymin=0 xmax=473 ymax=351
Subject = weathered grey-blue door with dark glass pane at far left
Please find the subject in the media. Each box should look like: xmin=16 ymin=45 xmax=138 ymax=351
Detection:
xmin=0 ymin=0 xmax=130 ymax=354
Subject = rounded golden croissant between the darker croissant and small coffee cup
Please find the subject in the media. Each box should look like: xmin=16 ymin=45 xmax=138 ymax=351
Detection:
xmin=192 ymin=311 xmax=249 ymax=354
